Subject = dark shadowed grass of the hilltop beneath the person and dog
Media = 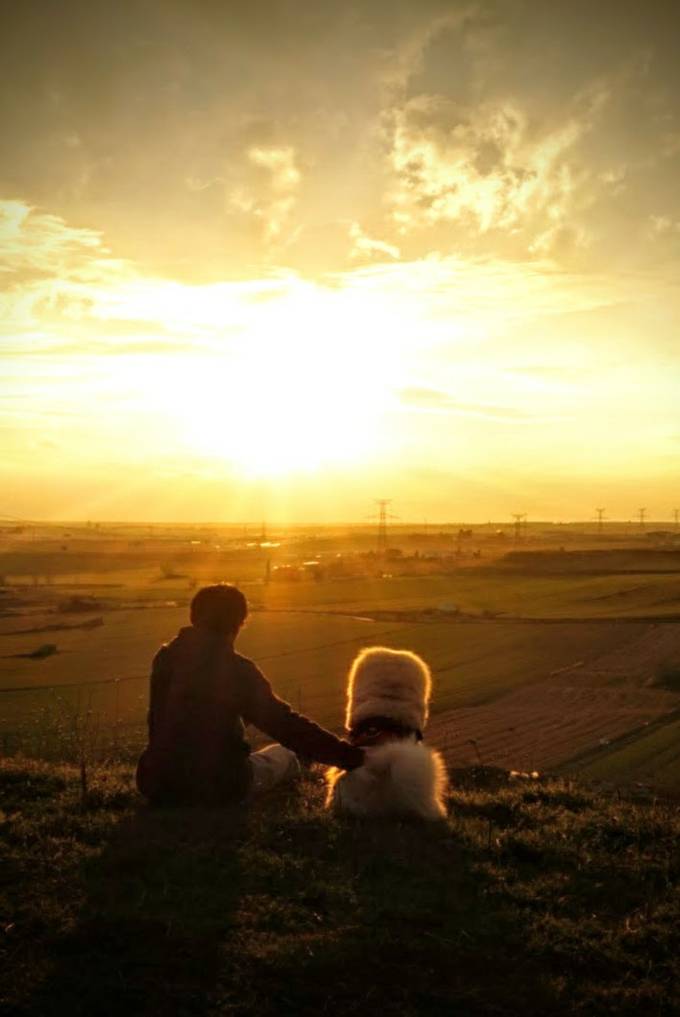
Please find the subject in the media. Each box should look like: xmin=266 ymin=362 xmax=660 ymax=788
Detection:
xmin=0 ymin=760 xmax=680 ymax=1017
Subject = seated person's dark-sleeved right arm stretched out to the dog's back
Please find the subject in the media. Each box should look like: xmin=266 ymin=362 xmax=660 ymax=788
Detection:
xmin=242 ymin=661 xmax=364 ymax=770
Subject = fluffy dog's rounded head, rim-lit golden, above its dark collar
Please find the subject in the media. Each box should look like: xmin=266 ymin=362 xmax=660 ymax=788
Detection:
xmin=345 ymin=646 xmax=432 ymax=731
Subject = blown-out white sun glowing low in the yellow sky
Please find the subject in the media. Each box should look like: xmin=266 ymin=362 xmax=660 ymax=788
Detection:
xmin=126 ymin=281 xmax=409 ymax=477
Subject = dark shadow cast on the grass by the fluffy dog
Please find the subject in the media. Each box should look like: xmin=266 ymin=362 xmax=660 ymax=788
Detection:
xmin=209 ymin=816 xmax=551 ymax=1017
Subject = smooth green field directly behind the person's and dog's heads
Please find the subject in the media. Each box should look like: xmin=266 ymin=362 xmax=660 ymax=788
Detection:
xmin=0 ymin=608 xmax=639 ymax=740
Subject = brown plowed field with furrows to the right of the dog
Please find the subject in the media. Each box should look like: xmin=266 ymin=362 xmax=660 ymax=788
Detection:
xmin=428 ymin=624 xmax=680 ymax=786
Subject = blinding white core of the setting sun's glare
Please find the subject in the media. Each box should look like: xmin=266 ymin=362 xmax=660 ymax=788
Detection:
xmin=146 ymin=291 xmax=402 ymax=477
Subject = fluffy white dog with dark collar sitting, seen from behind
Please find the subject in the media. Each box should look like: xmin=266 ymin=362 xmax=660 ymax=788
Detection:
xmin=326 ymin=646 xmax=447 ymax=820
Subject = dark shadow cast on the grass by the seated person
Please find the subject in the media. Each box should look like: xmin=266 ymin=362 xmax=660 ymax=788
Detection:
xmin=26 ymin=805 xmax=247 ymax=1017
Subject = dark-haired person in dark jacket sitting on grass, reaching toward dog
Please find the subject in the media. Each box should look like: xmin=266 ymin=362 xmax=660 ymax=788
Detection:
xmin=136 ymin=583 xmax=364 ymax=804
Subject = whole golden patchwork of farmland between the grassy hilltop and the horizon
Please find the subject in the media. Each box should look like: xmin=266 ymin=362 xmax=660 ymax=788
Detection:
xmin=0 ymin=539 xmax=680 ymax=785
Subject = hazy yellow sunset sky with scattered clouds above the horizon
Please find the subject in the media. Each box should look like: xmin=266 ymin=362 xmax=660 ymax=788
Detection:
xmin=0 ymin=0 xmax=680 ymax=521
